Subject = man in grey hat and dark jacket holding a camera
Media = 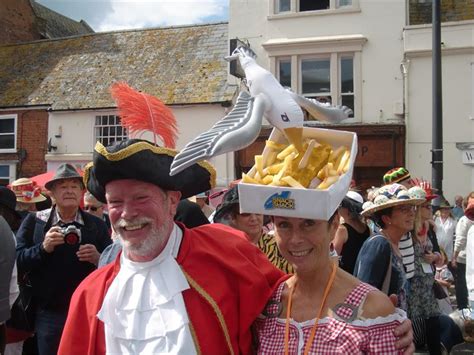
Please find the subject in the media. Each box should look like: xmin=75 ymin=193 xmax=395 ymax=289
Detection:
xmin=16 ymin=164 xmax=111 ymax=355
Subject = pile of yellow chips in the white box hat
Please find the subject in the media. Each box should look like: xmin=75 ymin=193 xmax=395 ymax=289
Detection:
xmin=242 ymin=139 xmax=351 ymax=190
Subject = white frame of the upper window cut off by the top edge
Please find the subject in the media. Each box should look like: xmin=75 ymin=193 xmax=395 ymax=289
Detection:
xmin=269 ymin=0 xmax=360 ymax=19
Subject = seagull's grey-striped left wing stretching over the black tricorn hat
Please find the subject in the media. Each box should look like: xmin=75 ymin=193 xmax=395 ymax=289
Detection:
xmin=170 ymin=91 xmax=267 ymax=176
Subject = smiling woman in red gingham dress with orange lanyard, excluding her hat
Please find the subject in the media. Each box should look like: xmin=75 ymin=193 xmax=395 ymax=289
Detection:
xmin=255 ymin=192 xmax=412 ymax=354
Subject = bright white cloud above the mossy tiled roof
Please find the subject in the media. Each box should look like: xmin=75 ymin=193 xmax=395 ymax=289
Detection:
xmin=94 ymin=0 xmax=228 ymax=32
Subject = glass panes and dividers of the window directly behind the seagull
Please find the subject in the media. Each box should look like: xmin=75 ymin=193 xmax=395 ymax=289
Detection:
xmin=277 ymin=53 xmax=357 ymax=117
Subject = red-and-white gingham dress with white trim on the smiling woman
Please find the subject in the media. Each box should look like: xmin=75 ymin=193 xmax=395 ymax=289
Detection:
xmin=256 ymin=282 xmax=406 ymax=354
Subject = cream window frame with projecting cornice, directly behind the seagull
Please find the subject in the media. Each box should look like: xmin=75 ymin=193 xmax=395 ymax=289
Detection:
xmin=262 ymin=34 xmax=367 ymax=123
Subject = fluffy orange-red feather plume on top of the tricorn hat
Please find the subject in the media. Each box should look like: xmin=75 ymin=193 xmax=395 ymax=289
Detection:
xmin=110 ymin=82 xmax=178 ymax=148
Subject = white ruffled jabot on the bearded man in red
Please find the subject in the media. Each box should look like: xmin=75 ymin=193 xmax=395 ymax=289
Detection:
xmin=97 ymin=225 xmax=196 ymax=354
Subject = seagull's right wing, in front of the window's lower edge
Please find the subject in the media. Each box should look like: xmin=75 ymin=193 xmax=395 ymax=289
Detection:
xmin=287 ymin=89 xmax=352 ymax=123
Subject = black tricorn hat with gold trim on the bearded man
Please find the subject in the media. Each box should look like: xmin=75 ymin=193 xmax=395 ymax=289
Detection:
xmin=84 ymin=139 xmax=216 ymax=203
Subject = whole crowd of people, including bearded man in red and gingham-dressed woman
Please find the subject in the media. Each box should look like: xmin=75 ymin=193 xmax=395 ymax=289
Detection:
xmin=0 ymin=89 xmax=474 ymax=355
